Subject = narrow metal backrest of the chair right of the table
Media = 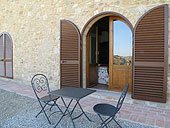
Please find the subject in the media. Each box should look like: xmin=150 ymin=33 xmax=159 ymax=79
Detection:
xmin=117 ymin=83 xmax=129 ymax=111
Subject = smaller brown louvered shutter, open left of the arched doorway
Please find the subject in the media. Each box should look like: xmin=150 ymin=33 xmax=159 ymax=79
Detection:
xmin=60 ymin=20 xmax=80 ymax=87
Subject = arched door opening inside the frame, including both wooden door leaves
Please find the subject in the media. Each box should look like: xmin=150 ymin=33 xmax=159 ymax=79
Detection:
xmin=86 ymin=16 xmax=132 ymax=92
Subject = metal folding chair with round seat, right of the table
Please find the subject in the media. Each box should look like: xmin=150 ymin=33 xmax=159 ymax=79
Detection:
xmin=93 ymin=84 xmax=129 ymax=128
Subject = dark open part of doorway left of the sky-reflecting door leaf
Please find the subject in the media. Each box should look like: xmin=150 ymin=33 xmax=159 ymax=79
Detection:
xmin=87 ymin=17 xmax=109 ymax=90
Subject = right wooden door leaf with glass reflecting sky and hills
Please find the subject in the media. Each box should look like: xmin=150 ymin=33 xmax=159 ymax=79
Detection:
xmin=109 ymin=17 xmax=132 ymax=92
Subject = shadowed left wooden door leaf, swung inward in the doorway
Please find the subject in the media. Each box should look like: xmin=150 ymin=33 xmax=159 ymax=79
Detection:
xmin=86 ymin=25 xmax=98 ymax=88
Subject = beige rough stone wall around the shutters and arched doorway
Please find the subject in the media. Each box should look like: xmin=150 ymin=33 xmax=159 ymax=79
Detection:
xmin=0 ymin=0 xmax=170 ymax=93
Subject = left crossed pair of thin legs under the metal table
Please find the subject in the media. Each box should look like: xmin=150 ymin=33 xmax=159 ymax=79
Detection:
xmin=54 ymin=97 xmax=75 ymax=128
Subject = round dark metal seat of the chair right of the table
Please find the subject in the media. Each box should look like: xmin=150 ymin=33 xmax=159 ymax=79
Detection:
xmin=93 ymin=104 xmax=117 ymax=116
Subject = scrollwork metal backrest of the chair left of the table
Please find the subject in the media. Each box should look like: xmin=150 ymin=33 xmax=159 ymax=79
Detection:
xmin=31 ymin=74 xmax=50 ymax=99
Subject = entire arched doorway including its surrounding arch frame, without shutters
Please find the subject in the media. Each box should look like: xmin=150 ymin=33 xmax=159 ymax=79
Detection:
xmin=82 ymin=12 xmax=133 ymax=91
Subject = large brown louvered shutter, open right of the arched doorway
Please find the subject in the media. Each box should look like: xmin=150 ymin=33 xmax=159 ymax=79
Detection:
xmin=132 ymin=5 xmax=168 ymax=102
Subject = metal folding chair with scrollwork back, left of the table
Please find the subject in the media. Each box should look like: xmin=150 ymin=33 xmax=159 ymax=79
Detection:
xmin=31 ymin=74 xmax=63 ymax=124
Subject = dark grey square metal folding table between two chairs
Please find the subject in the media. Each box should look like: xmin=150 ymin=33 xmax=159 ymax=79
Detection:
xmin=49 ymin=87 xmax=95 ymax=128
